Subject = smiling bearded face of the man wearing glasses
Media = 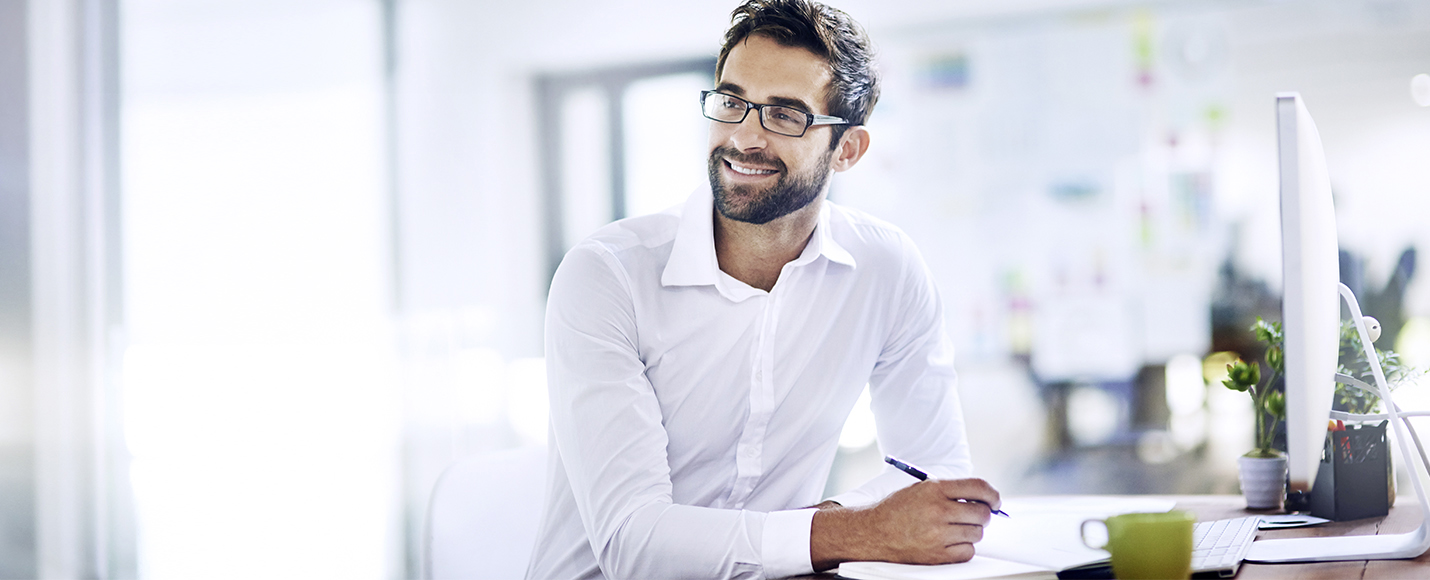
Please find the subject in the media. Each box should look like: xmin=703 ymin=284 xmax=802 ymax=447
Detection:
xmin=709 ymin=34 xmax=834 ymax=224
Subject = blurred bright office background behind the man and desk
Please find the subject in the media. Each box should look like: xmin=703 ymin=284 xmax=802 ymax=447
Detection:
xmin=0 ymin=0 xmax=1430 ymax=579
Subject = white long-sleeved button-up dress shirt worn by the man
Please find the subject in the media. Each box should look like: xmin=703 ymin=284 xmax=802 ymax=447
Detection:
xmin=528 ymin=187 xmax=971 ymax=580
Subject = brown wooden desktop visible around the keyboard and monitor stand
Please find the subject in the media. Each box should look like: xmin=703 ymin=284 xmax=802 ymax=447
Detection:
xmin=1170 ymin=496 xmax=1430 ymax=580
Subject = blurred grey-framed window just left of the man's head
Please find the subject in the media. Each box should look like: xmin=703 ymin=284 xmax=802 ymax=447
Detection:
xmin=536 ymin=59 xmax=715 ymax=281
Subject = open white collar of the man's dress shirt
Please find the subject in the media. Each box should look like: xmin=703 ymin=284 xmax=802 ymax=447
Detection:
xmin=661 ymin=186 xmax=857 ymax=287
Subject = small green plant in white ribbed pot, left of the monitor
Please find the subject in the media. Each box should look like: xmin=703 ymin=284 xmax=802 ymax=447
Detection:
xmin=1221 ymin=319 xmax=1286 ymax=510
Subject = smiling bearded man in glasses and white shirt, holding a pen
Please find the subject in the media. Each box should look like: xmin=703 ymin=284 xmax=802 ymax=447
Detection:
xmin=528 ymin=0 xmax=1000 ymax=579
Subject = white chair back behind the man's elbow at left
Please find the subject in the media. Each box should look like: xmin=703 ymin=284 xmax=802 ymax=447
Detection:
xmin=422 ymin=446 xmax=546 ymax=580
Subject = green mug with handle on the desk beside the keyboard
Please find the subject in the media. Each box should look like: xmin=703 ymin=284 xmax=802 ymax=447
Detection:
xmin=1081 ymin=511 xmax=1197 ymax=580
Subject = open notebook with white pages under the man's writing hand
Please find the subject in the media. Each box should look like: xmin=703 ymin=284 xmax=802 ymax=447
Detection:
xmin=839 ymin=496 xmax=1175 ymax=580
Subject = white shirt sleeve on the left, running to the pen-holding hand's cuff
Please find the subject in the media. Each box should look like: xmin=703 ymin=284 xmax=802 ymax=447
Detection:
xmin=546 ymin=244 xmax=812 ymax=579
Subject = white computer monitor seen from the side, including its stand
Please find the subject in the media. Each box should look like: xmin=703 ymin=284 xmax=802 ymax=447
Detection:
xmin=1246 ymin=93 xmax=1430 ymax=561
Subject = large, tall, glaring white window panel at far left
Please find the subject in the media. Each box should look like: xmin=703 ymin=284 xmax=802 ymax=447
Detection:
xmin=120 ymin=0 xmax=402 ymax=580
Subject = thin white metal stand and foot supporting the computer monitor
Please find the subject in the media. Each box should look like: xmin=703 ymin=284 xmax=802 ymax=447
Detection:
xmin=1246 ymin=284 xmax=1430 ymax=563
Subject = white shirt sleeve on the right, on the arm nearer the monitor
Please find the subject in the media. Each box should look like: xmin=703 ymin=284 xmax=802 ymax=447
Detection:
xmin=832 ymin=236 xmax=972 ymax=506
